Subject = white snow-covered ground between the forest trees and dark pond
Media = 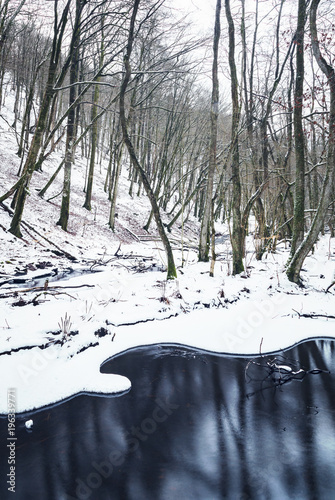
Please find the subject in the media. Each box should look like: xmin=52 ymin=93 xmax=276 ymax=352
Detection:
xmin=0 ymin=78 xmax=335 ymax=414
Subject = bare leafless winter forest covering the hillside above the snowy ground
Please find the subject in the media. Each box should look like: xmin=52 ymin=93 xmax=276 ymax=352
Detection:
xmin=0 ymin=0 xmax=335 ymax=283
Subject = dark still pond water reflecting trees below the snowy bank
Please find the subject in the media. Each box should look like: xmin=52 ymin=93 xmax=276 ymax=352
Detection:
xmin=0 ymin=340 xmax=335 ymax=500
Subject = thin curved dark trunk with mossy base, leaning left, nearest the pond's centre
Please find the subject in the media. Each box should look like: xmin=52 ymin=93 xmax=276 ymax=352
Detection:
xmin=120 ymin=0 xmax=177 ymax=279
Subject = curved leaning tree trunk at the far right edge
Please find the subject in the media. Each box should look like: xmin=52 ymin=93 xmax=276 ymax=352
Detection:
xmin=286 ymin=0 xmax=335 ymax=283
